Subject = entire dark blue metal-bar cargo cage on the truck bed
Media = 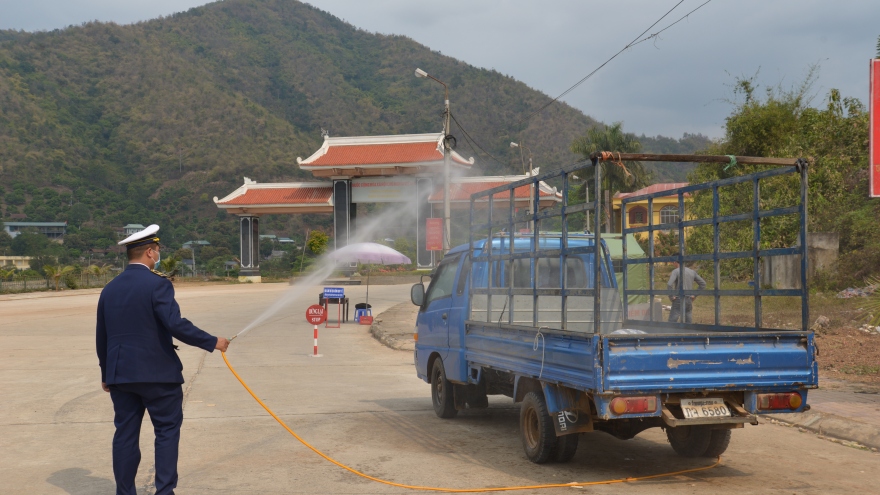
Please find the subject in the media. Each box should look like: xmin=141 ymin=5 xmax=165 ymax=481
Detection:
xmin=468 ymin=152 xmax=809 ymax=334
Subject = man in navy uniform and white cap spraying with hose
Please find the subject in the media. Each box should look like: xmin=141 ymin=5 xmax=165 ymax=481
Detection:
xmin=96 ymin=225 xmax=229 ymax=495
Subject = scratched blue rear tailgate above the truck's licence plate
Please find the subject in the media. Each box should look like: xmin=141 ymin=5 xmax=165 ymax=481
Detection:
xmin=600 ymin=332 xmax=818 ymax=394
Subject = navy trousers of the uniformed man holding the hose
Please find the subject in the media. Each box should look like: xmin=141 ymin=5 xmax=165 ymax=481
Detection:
xmin=110 ymin=383 xmax=183 ymax=495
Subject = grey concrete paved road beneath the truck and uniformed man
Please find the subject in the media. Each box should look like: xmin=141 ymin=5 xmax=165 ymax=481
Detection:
xmin=0 ymin=284 xmax=880 ymax=495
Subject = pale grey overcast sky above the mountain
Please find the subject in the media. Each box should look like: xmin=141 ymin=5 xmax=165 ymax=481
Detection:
xmin=0 ymin=0 xmax=880 ymax=137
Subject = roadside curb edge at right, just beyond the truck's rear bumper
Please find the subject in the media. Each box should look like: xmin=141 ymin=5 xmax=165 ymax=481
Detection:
xmin=763 ymin=411 xmax=880 ymax=452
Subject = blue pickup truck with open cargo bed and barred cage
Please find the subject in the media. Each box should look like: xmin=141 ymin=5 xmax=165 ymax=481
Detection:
xmin=411 ymin=154 xmax=818 ymax=463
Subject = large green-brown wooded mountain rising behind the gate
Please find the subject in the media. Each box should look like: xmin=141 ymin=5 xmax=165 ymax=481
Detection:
xmin=0 ymin=0 xmax=704 ymax=264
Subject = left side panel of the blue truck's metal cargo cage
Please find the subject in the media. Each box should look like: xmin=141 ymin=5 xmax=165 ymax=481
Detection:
xmin=469 ymin=162 xmax=622 ymax=333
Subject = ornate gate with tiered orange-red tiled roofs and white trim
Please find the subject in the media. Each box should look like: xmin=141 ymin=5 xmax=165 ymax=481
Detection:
xmin=214 ymin=133 xmax=561 ymax=282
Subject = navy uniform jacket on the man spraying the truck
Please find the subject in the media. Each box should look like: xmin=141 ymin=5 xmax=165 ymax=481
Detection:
xmin=96 ymin=263 xmax=217 ymax=385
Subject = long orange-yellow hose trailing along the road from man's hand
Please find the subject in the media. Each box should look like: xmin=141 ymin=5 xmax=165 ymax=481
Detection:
xmin=222 ymin=352 xmax=721 ymax=493
